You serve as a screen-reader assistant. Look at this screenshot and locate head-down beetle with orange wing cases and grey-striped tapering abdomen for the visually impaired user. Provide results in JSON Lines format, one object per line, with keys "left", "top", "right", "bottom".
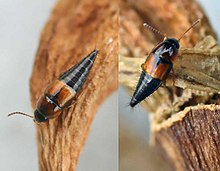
{"left": 8, "top": 50, "right": 98, "bottom": 123}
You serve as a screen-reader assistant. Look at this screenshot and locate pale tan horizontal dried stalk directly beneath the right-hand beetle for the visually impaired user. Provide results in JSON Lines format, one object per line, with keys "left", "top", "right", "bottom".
{"left": 119, "top": 36, "right": 220, "bottom": 93}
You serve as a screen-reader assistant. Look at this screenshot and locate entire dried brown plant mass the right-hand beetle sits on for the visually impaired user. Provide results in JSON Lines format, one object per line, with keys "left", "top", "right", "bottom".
{"left": 119, "top": 0, "right": 220, "bottom": 171}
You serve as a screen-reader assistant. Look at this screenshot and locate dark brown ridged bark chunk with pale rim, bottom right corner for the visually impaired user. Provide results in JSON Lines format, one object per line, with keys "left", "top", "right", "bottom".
{"left": 154, "top": 105, "right": 220, "bottom": 171}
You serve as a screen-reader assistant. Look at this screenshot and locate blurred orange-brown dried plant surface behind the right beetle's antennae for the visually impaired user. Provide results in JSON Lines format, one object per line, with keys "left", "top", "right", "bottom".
{"left": 120, "top": 0, "right": 216, "bottom": 57}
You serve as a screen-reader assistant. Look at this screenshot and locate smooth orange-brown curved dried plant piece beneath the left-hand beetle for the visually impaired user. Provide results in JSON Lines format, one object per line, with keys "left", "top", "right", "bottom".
{"left": 30, "top": 0, "right": 119, "bottom": 171}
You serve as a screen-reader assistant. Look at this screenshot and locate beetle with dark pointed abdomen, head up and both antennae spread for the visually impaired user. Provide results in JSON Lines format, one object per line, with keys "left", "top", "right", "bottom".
{"left": 130, "top": 19, "right": 200, "bottom": 107}
